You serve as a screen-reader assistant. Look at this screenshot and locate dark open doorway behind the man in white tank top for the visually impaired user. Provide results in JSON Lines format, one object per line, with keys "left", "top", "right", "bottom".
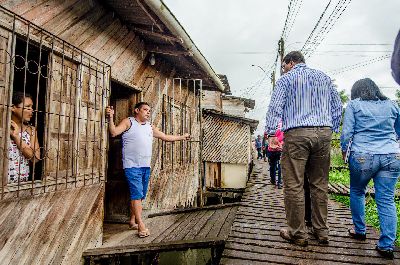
{"left": 105, "top": 81, "right": 140, "bottom": 222}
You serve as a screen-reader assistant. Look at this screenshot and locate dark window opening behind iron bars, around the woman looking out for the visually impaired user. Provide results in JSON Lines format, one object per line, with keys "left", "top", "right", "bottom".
{"left": 13, "top": 38, "right": 49, "bottom": 180}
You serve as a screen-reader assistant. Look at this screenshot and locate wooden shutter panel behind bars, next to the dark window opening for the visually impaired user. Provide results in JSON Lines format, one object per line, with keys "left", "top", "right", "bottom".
{"left": 44, "top": 54, "right": 78, "bottom": 178}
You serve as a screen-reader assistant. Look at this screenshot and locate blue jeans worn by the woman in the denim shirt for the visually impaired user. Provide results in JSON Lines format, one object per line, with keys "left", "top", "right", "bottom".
{"left": 349, "top": 152, "right": 400, "bottom": 250}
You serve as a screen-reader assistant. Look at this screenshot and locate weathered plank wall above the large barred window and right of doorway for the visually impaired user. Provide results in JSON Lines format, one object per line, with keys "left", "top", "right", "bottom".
{"left": 0, "top": 0, "right": 200, "bottom": 209}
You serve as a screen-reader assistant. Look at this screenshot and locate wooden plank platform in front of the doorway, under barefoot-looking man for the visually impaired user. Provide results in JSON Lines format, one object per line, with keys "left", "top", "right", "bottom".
{"left": 83, "top": 204, "right": 239, "bottom": 264}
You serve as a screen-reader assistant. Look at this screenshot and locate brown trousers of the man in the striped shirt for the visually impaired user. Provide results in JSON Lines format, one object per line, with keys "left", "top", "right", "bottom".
{"left": 281, "top": 127, "right": 332, "bottom": 239}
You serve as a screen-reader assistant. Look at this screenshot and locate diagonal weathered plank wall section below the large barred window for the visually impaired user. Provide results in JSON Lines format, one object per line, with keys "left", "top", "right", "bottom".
{"left": 0, "top": 184, "right": 104, "bottom": 265}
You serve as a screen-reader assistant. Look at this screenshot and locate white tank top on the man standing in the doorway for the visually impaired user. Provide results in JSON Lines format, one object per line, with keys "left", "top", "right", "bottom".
{"left": 122, "top": 117, "right": 153, "bottom": 168}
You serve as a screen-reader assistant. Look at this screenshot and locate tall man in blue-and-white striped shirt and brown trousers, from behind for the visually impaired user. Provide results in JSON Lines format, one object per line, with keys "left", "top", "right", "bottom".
{"left": 265, "top": 51, "right": 342, "bottom": 246}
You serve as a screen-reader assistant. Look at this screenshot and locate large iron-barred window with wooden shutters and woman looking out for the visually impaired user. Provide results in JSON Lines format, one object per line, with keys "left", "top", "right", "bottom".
{"left": 0, "top": 11, "right": 111, "bottom": 198}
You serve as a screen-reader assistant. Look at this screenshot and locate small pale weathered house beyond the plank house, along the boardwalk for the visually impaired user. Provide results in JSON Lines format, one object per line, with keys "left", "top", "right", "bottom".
{"left": 202, "top": 77, "right": 258, "bottom": 202}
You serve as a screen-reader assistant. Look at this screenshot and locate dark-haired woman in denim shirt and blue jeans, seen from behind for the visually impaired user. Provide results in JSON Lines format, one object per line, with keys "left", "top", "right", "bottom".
{"left": 340, "top": 78, "right": 400, "bottom": 259}
